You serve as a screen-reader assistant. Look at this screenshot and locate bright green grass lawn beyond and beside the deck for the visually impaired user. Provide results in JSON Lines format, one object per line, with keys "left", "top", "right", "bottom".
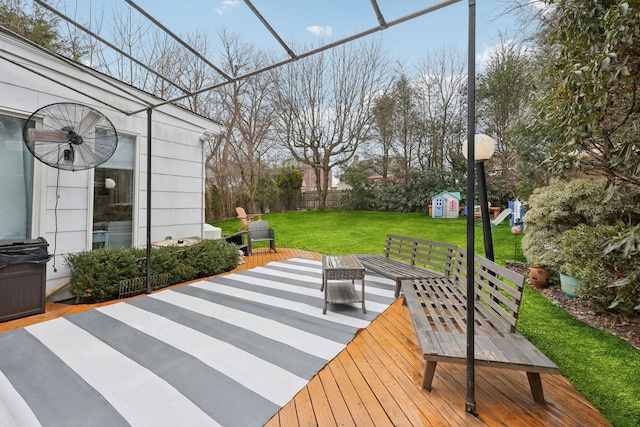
{"left": 214, "top": 211, "right": 640, "bottom": 427}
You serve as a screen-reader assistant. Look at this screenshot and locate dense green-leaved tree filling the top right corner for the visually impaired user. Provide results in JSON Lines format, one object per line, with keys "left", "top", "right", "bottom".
{"left": 538, "top": 0, "right": 640, "bottom": 185}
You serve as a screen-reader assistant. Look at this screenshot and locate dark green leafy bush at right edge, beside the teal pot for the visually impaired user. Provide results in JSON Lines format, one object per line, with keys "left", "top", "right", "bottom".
{"left": 563, "top": 224, "right": 640, "bottom": 316}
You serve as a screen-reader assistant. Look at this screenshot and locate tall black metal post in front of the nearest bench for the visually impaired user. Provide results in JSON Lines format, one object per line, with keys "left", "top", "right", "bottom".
{"left": 465, "top": 0, "right": 478, "bottom": 416}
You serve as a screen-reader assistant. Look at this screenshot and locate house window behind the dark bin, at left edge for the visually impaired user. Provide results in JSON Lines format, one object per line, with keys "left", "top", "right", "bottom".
{"left": 0, "top": 114, "right": 35, "bottom": 240}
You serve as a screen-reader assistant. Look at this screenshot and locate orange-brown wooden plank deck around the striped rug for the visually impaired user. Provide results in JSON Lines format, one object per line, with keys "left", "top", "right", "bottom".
{"left": 0, "top": 249, "right": 611, "bottom": 427}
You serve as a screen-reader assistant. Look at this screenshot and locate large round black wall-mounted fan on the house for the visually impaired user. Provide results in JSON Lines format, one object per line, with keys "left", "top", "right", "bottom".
{"left": 22, "top": 102, "right": 118, "bottom": 171}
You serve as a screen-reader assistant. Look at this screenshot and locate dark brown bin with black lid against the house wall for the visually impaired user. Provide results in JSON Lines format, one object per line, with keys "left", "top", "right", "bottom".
{"left": 0, "top": 237, "right": 51, "bottom": 322}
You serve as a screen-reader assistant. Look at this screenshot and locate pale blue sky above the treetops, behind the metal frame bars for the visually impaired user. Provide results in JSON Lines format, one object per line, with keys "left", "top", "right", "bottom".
{"left": 123, "top": 0, "right": 519, "bottom": 67}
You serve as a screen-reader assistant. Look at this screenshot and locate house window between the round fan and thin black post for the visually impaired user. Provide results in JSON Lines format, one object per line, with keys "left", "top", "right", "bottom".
{"left": 92, "top": 133, "right": 136, "bottom": 249}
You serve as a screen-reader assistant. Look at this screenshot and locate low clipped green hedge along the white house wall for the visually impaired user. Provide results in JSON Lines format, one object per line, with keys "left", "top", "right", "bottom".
{"left": 65, "top": 240, "right": 238, "bottom": 303}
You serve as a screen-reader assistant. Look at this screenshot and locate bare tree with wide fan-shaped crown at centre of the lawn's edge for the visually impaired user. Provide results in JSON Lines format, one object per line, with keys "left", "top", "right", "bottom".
{"left": 276, "top": 42, "right": 388, "bottom": 209}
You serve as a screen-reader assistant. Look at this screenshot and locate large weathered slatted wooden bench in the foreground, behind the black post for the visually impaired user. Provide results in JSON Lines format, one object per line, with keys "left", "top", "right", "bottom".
{"left": 402, "top": 242, "right": 560, "bottom": 404}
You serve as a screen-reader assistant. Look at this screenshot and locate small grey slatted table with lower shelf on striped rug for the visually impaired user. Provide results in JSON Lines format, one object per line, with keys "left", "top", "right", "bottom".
{"left": 320, "top": 255, "right": 367, "bottom": 314}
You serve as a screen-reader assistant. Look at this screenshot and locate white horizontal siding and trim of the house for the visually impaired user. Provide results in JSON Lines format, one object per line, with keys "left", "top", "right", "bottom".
{"left": 0, "top": 32, "right": 221, "bottom": 299}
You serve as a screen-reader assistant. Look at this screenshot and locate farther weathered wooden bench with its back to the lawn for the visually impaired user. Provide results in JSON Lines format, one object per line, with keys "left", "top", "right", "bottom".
{"left": 357, "top": 234, "right": 457, "bottom": 298}
